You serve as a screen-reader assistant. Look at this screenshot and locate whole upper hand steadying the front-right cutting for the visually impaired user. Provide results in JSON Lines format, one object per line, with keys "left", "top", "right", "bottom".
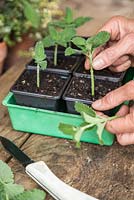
{"left": 85, "top": 16, "right": 134, "bottom": 72}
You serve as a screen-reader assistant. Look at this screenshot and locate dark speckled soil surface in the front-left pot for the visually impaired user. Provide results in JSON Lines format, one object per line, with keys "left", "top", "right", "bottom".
{"left": 12, "top": 70, "right": 67, "bottom": 96}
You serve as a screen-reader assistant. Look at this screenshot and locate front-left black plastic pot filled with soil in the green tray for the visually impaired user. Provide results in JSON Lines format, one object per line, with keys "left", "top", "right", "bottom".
{"left": 11, "top": 70, "right": 70, "bottom": 111}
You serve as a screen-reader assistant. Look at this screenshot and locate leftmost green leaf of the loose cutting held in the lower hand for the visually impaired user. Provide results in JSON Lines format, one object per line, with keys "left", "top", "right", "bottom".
{"left": 58, "top": 123, "right": 77, "bottom": 136}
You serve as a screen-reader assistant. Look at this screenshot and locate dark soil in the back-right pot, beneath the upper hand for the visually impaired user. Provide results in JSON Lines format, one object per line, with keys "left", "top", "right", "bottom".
{"left": 75, "top": 61, "right": 125, "bottom": 81}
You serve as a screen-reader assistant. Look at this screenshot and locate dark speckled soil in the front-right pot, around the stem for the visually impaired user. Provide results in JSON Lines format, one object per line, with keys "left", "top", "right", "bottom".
{"left": 65, "top": 77, "right": 119, "bottom": 101}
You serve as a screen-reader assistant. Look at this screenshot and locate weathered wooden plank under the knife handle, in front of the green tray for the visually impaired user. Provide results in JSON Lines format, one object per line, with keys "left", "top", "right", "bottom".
{"left": 9, "top": 135, "right": 134, "bottom": 200}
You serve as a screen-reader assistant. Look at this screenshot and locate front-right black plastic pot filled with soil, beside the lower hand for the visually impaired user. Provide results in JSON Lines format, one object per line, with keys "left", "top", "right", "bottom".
{"left": 63, "top": 77, "right": 120, "bottom": 116}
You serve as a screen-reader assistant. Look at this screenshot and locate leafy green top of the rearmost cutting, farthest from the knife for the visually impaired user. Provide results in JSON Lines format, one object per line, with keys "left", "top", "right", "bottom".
{"left": 49, "top": 8, "right": 92, "bottom": 29}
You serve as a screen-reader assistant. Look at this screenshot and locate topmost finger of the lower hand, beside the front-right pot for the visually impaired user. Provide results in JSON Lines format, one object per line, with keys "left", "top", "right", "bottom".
{"left": 92, "top": 80, "right": 134, "bottom": 111}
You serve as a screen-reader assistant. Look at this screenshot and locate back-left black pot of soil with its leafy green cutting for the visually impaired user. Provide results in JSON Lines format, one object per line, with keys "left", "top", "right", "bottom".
{"left": 26, "top": 26, "right": 81, "bottom": 75}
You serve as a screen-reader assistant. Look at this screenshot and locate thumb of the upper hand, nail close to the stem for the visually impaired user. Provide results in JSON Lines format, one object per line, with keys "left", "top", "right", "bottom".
{"left": 93, "top": 33, "right": 134, "bottom": 70}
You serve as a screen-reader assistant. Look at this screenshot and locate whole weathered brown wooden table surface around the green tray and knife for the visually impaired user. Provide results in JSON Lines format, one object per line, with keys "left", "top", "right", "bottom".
{"left": 0, "top": 0, "right": 134, "bottom": 200}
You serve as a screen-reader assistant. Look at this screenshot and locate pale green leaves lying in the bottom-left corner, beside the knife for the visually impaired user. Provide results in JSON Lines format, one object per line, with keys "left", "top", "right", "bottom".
{"left": 0, "top": 160, "right": 46, "bottom": 200}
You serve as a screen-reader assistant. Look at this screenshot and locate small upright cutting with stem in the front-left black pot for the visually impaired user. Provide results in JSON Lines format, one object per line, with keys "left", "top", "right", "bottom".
{"left": 33, "top": 41, "right": 47, "bottom": 88}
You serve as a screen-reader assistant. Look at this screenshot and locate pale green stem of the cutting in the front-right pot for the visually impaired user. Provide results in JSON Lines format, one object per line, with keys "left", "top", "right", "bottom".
{"left": 88, "top": 53, "right": 95, "bottom": 96}
